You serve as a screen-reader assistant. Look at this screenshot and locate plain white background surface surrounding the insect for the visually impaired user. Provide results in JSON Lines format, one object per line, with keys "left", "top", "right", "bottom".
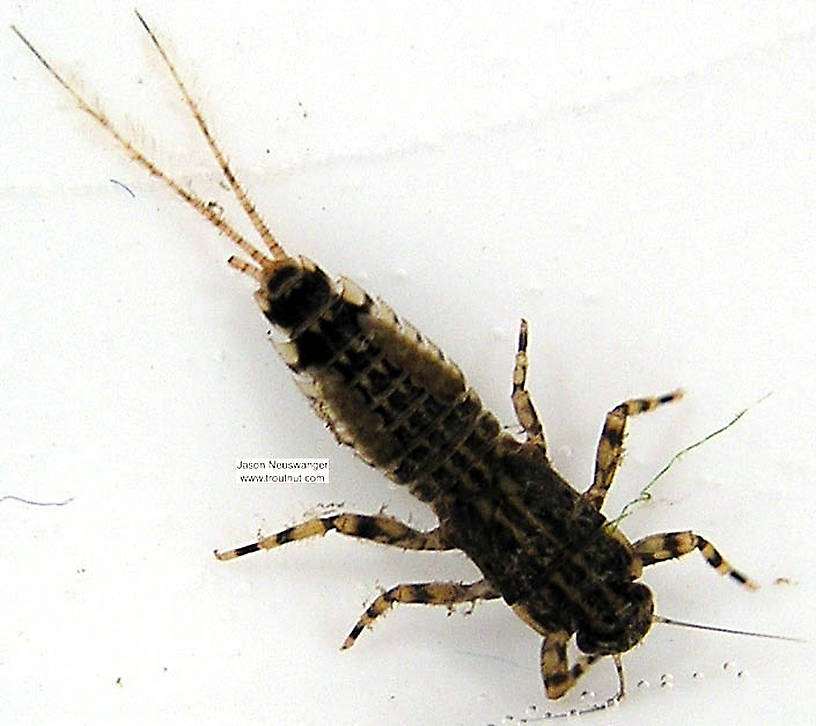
{"left": 0, "top": 0, "right": 816, "bottom": 725}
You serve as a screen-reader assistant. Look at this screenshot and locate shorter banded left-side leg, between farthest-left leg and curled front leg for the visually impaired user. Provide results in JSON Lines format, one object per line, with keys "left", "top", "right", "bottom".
{"left": 342, "top": 580, "right": 500, "bottom": 650}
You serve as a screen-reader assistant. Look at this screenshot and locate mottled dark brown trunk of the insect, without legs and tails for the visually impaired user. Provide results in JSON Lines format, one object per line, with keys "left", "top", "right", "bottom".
{"left": 256, "top": 259, "right": 651, "bottom": 656}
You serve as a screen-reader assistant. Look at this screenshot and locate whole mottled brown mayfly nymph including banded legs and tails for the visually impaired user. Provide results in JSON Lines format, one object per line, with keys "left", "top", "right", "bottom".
{"left": 15, "top": 16, "right": 753, "bottom": 710}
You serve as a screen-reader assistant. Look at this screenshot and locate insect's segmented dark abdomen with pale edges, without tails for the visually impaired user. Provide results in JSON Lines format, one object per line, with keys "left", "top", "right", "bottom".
{"left": 256, "top": 260, "right": 501, "bottom": 504}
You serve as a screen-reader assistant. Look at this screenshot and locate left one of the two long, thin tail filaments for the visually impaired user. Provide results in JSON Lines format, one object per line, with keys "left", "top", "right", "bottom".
{"left": 11, "top": 25, "right": 272, "bottom": 280}
